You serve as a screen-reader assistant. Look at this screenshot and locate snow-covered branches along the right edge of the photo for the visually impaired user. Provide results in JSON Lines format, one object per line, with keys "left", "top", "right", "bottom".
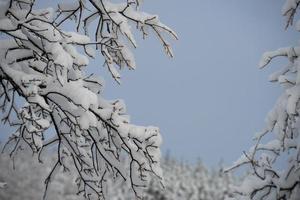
{"left": 228, "top": 0, "right": 300, "bottom": 200}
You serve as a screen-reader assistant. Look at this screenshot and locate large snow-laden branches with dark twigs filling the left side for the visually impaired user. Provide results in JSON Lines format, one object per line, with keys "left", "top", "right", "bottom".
{"left": 0, "top": 0, "right": 177, "bottom": 199}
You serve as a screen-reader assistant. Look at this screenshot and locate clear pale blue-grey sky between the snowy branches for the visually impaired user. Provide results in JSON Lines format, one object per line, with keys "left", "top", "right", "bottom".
{"left": 1, "top": 0, "right": 298, "bottom": 165}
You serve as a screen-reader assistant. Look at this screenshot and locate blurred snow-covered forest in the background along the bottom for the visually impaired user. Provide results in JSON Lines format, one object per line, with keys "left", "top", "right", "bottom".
{"left": 0, "top": 152, "right": 234, "bottom": 200}
